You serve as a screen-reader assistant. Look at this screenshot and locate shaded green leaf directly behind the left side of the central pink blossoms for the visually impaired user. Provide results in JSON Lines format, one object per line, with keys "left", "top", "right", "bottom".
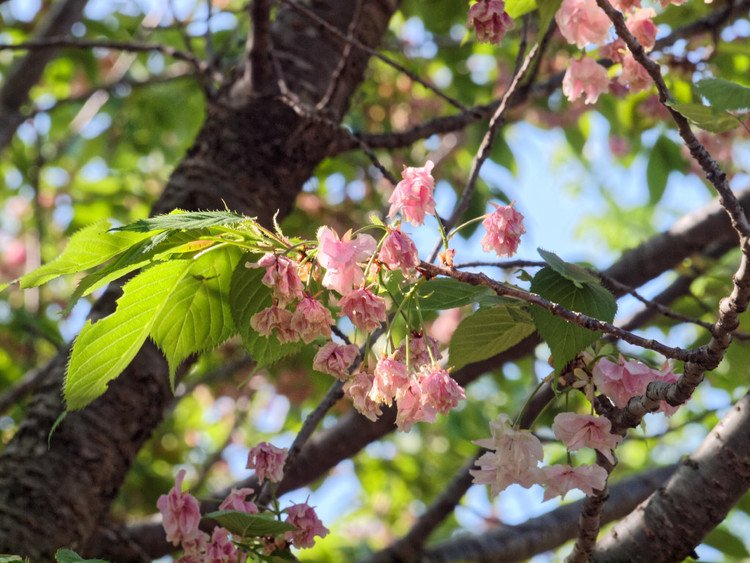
{"left": 229, "top": 254, "right": 302, "bottom": 367}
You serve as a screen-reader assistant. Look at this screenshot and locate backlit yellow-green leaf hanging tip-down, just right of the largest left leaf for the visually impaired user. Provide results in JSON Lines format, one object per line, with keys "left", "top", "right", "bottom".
{"left": 151, "top": 247, "right": 241, "bottom": 386}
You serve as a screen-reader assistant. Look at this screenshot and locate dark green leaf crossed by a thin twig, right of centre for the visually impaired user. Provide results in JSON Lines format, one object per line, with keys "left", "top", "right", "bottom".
{"left": 531, "top": 267, "right": 617, "bottom": 370}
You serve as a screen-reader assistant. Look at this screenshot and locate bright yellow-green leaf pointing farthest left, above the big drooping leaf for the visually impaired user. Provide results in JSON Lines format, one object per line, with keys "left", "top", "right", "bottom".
{"left": 19, "top": 220, "right": 152, "bottom": 288}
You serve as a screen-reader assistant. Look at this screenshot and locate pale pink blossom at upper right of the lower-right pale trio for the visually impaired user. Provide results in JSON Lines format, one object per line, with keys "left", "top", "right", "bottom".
{"left": 552, "top": 412, "right": 622, "bottom": 463}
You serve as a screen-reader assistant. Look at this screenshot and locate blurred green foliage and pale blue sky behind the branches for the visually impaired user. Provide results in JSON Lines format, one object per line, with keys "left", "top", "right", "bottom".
{"left": 0, "top": 0, "right": 750, "bottom": 561}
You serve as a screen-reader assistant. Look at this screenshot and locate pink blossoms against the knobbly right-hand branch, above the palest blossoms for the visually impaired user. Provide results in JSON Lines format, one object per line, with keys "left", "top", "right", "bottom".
{"left": 593, "top": 356, "right": 679, "bottom": 416}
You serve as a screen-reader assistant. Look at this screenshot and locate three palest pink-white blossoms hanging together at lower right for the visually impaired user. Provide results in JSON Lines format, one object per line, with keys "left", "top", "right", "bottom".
{"left": 470, "top": 413, "right": 621, "bottom": 500}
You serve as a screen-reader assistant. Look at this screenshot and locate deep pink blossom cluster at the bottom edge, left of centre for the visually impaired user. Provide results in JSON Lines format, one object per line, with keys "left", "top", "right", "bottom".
{"left": 156, "top": 442, "right": 328, "bottom": 563}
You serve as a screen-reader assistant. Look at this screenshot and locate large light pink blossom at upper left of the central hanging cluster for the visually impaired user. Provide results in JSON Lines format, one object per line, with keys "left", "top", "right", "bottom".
{"left": 318, "top": 227, "right": 377, "bottom": 295}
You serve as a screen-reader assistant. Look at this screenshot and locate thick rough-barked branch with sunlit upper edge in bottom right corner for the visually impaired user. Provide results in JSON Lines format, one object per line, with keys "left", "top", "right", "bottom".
{"left": 593, "top": 395, "right": 750, "bottom": 563}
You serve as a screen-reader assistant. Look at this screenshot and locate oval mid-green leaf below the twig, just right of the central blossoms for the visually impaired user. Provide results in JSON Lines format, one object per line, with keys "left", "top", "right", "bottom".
{"left": 449, "top": 305, "right": 534, "bottom": 369}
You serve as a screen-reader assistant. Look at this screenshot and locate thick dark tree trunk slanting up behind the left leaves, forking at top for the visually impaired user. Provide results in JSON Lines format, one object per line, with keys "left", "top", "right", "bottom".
{"left": 0, "top": 0, "right": 398, "bottom": 561}
